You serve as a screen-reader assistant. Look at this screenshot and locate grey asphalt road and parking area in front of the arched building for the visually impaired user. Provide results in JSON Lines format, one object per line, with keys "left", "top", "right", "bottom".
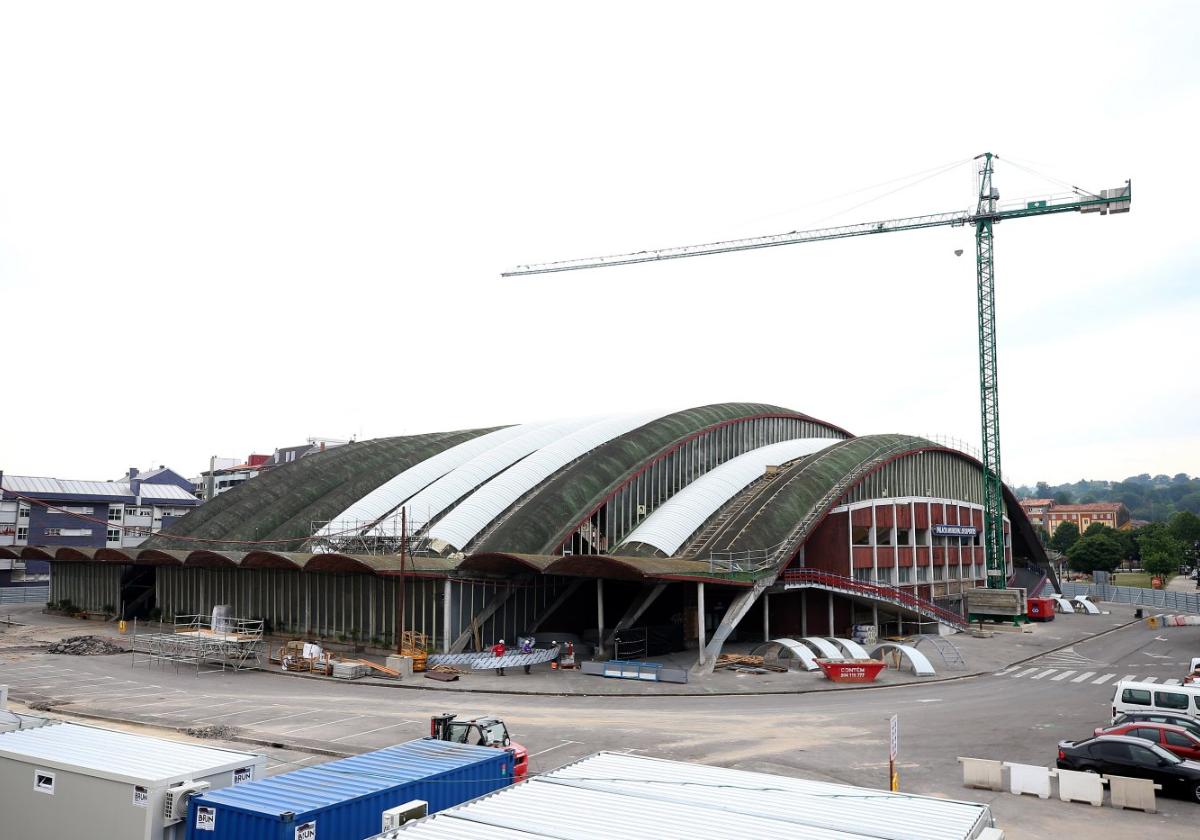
{"left": 0, "top": 606, "right": 1200, "bottom": 840}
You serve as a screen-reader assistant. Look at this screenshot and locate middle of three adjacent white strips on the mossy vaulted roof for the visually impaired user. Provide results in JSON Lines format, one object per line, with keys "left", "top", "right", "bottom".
{"left": 370, "top": 418, "right": 595, "bottom": 536}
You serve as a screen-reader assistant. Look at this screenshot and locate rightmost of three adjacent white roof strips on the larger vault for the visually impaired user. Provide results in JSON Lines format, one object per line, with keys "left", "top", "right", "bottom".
{"left": 427, "top": 412, "right": 672, "bottom": 548}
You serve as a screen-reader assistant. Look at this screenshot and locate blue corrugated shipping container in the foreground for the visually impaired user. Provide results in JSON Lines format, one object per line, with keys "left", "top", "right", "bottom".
{"left": 187, "top": 738, "right": 512, "bottom": 840}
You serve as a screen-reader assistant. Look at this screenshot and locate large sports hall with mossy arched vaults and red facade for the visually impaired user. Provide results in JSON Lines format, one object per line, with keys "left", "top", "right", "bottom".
{"left": 0, "top": 403, "right": 1052, "bottom": 667}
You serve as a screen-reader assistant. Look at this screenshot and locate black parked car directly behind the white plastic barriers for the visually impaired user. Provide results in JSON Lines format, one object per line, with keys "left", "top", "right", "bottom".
{"left": 1057, "top": 736, "right": 1200, "bottom": 803}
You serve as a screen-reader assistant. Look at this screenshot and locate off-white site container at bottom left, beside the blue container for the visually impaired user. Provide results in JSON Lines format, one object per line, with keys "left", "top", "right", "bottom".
{"left": 0, "top": 724, "right": 266, "bottom": 840}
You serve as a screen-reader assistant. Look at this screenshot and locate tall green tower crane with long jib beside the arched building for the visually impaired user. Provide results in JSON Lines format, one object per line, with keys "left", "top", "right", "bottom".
{"left": 500, "top": 152, "right": 1132, "bottom": 589}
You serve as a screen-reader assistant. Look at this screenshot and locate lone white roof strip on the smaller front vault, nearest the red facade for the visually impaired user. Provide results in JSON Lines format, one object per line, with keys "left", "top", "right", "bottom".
{"left": 622, "top": 438, "right": 836, "bottom": 556}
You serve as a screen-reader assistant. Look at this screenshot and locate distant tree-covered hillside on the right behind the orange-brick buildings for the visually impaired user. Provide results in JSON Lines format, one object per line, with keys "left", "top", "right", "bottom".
{"left": 1015, "top": 473, "right": 1200, "bottom": 522}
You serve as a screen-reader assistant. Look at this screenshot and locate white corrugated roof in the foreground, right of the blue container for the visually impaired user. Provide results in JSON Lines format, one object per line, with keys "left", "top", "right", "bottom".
{"left": 384, "top": 752, "right": 992, "bottom": 840}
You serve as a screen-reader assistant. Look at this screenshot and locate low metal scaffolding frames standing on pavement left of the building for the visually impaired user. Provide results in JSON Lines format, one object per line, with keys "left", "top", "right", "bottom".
{"left": 130, "top": 616, "right": 264, "bottom": 674}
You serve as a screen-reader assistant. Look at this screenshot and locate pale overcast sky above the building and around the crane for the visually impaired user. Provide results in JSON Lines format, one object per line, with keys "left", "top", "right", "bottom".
{"left": 0, "top": 0, "right": 1200, "bottom": 484}
